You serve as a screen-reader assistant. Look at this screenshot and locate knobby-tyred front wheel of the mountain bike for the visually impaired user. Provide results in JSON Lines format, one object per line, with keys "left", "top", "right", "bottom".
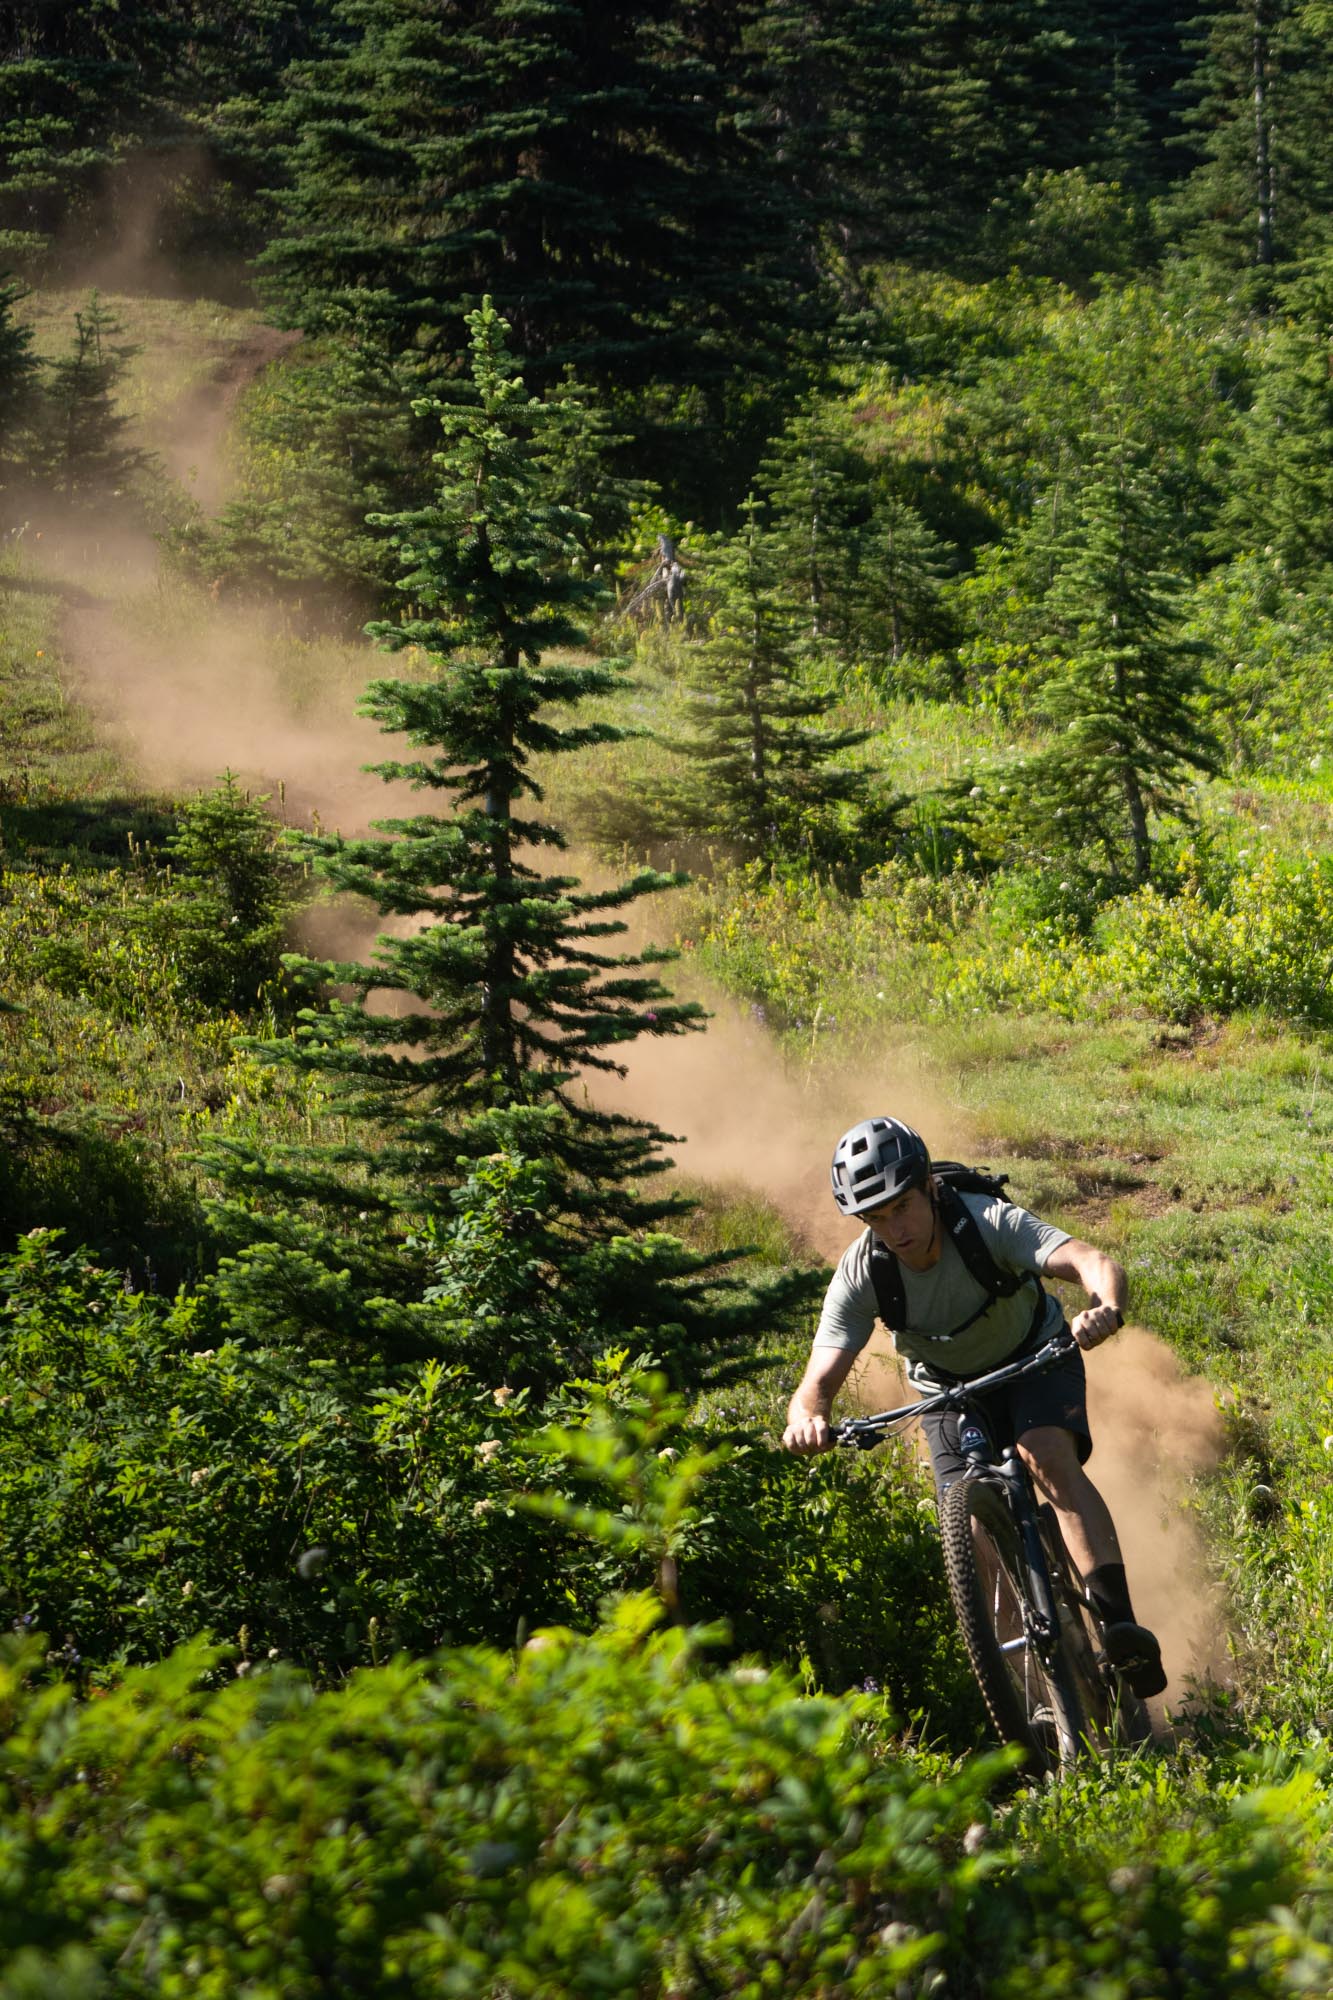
{"left": 939, "top": 1476, "right": 1087, "bottom": 1774}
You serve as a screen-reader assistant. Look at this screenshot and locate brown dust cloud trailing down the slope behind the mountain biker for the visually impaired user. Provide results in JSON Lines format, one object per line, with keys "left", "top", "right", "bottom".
{"left": 36, "top": 296, "right": 1223, "bottom": 1694}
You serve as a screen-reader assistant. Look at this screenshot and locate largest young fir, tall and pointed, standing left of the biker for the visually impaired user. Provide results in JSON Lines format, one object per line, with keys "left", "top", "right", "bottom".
{"left": 202, "top": 302, "right": 809, "bottom": 1386}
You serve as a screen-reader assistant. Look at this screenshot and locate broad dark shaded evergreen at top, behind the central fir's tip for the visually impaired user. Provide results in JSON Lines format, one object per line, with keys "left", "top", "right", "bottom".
{"left": 260, "top": 0, "right": 813, "bottom": 406}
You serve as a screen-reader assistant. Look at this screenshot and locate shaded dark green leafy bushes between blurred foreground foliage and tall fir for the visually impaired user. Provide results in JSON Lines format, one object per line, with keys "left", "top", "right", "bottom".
{"left": 0, "top": 1232, "right": 979, "bottom": 1742}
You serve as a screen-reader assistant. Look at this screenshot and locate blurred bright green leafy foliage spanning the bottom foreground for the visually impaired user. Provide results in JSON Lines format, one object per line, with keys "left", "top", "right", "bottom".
{"left": 0, "top": 1596, "right": 1333, "bottom": 2000}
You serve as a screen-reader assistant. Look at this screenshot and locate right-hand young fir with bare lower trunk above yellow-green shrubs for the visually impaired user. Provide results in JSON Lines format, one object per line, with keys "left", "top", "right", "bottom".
{"left": 999, "top": 440, "right": 1217, "bottom": 888}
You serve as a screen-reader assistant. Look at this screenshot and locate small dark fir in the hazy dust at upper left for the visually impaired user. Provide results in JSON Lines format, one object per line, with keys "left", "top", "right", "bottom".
{"left": 36, "top": 292, "right": 148, "bottom": 506}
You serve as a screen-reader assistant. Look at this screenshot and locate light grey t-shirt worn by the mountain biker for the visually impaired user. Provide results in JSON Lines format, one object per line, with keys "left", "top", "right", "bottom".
{"left": 815, "top": 1194, "right": 1069, "bottom": 1386}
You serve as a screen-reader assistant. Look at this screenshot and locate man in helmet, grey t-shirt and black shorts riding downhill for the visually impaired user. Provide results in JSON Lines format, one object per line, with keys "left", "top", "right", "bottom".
{"left": 783, "top": 1118, "right": 1167, "bottom": 1696}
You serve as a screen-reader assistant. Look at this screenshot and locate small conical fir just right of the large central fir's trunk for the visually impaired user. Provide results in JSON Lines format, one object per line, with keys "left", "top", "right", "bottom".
{"left": 667, "top": 496, "right": 869, "bottom": 864}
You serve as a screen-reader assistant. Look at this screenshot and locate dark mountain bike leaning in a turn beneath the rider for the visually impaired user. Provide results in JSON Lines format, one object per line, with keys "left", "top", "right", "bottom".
{"left": 833, "top": 1332, "right": 1153, "bottom": 1776}
